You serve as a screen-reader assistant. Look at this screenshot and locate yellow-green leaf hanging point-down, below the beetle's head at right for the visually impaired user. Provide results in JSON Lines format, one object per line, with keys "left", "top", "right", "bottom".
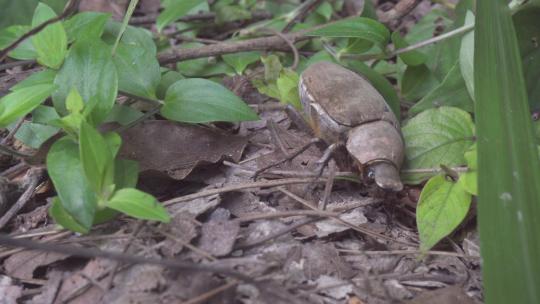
{"left": 416, "top": 175, "right": 471, "bottom": 252}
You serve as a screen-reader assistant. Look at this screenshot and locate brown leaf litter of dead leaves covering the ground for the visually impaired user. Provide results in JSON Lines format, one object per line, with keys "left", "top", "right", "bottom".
{"left": 0, "top": 0, "right": 482, "bottom": 304}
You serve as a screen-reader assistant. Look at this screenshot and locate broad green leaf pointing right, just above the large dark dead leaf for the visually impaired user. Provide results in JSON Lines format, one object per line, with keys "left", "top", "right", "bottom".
{"left": 161, "top": 78, "right": 259, "bottom": 123}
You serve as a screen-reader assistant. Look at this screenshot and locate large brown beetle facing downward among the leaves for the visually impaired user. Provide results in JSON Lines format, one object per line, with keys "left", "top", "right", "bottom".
{"left": 298, "top": 61, "right": 404, "bottom": 191}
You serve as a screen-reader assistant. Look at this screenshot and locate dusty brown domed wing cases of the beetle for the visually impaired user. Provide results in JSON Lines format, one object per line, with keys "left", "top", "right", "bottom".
{"left": 300, "top": 62, "right": 398, "bottom": 127}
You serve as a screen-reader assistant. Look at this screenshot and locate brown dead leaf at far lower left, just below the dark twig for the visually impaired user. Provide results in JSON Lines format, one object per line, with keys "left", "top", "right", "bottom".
{"left": 4, "top": 250, "right": 68, "bottom": 279}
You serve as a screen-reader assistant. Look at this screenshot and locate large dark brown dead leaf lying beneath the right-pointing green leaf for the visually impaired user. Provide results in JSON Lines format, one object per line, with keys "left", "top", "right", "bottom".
{"left": 120, "top": 120, "right": 247, "bottom": 180}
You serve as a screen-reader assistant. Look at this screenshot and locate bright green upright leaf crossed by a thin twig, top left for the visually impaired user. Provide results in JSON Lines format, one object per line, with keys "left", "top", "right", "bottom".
{"left": 32, "top": 3, "right": 67, "bottom": 69}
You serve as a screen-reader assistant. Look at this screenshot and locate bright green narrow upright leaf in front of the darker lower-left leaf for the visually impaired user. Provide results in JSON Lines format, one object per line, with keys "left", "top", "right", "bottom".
{"left": 79, "top": 121, "right": 114, "bottom": 199}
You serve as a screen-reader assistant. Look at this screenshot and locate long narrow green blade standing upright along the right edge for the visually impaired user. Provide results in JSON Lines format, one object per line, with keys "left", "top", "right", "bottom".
{"left": 474, "top": 0, "right": 540, "bottom": 304}
